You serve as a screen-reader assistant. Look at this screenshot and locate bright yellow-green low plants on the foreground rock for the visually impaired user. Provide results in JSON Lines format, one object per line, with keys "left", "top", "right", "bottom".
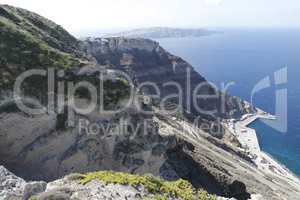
{"left": 80, "top": 171, "right": 216, "bottom": 200}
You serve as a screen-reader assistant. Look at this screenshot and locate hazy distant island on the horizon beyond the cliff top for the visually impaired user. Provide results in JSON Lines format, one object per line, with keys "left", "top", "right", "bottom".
{"left": 104, "top": 27, "right": 220, "bottom": 39}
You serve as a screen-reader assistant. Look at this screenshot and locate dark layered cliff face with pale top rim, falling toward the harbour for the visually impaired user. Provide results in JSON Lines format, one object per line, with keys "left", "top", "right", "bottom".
{"left": 84, "top": 38, "right": 254, "bottom": 121}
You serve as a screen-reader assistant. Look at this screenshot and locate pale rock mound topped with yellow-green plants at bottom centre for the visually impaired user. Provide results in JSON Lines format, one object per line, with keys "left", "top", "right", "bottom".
{"left": 32, "top": 171, "right": 226, "bottom": 200}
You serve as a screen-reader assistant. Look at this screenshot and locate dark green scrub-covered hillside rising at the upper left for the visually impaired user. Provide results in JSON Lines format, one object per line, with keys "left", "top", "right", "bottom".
{"left": 0, "top": 5, "right": 86, "bottom": 87}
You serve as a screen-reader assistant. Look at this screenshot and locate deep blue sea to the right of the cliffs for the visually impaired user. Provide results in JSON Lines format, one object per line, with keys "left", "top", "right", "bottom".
{"left": 158, "top": 29, "right": 300, "bottom": 176}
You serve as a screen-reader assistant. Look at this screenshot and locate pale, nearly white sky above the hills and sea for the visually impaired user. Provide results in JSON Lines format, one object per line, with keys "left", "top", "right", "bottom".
{"left": 0, "top": 0, "right": 300, "bottom": 35}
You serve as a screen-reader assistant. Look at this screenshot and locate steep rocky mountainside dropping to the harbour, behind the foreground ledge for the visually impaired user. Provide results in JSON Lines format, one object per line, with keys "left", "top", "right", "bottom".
{"left": 0, "top": 6, "right": 300, "bottom": 200}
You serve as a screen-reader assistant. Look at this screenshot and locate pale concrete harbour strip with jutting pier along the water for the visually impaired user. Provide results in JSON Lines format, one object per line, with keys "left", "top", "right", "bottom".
{"left": 225, "top": 109, "right": 300, "bottom": 183}
